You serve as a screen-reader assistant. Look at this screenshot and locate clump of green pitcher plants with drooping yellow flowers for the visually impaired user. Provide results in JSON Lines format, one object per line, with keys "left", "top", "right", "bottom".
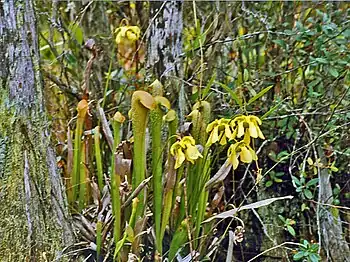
{"left": 66, "top": 77, "right": 264, "bottom": 261}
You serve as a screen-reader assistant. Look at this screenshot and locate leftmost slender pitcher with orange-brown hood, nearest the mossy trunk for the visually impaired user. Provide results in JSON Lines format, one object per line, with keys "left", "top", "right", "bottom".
{"left": 72, "top": 99, "right": 88, "bottom": 203}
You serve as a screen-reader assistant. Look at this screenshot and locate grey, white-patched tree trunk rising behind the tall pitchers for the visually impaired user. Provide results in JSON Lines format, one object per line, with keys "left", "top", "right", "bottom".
{"left": 147, "top": 1, "right": 186, "bottom": 122}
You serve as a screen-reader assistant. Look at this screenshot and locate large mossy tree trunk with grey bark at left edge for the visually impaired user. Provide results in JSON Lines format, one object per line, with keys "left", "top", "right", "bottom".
{"left": 0, "top": 0, "right": 73, "bottom": 261}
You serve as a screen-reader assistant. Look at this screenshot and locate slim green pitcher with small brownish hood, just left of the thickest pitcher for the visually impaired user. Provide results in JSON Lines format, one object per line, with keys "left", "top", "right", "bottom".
{"left": 111, "top": 112, "right": 125, "bottom": 247}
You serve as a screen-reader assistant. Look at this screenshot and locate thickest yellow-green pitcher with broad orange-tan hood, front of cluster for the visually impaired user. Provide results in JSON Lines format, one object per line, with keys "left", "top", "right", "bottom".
{"left": 131, "top": 91, "right": 155, "bottom": 219}
